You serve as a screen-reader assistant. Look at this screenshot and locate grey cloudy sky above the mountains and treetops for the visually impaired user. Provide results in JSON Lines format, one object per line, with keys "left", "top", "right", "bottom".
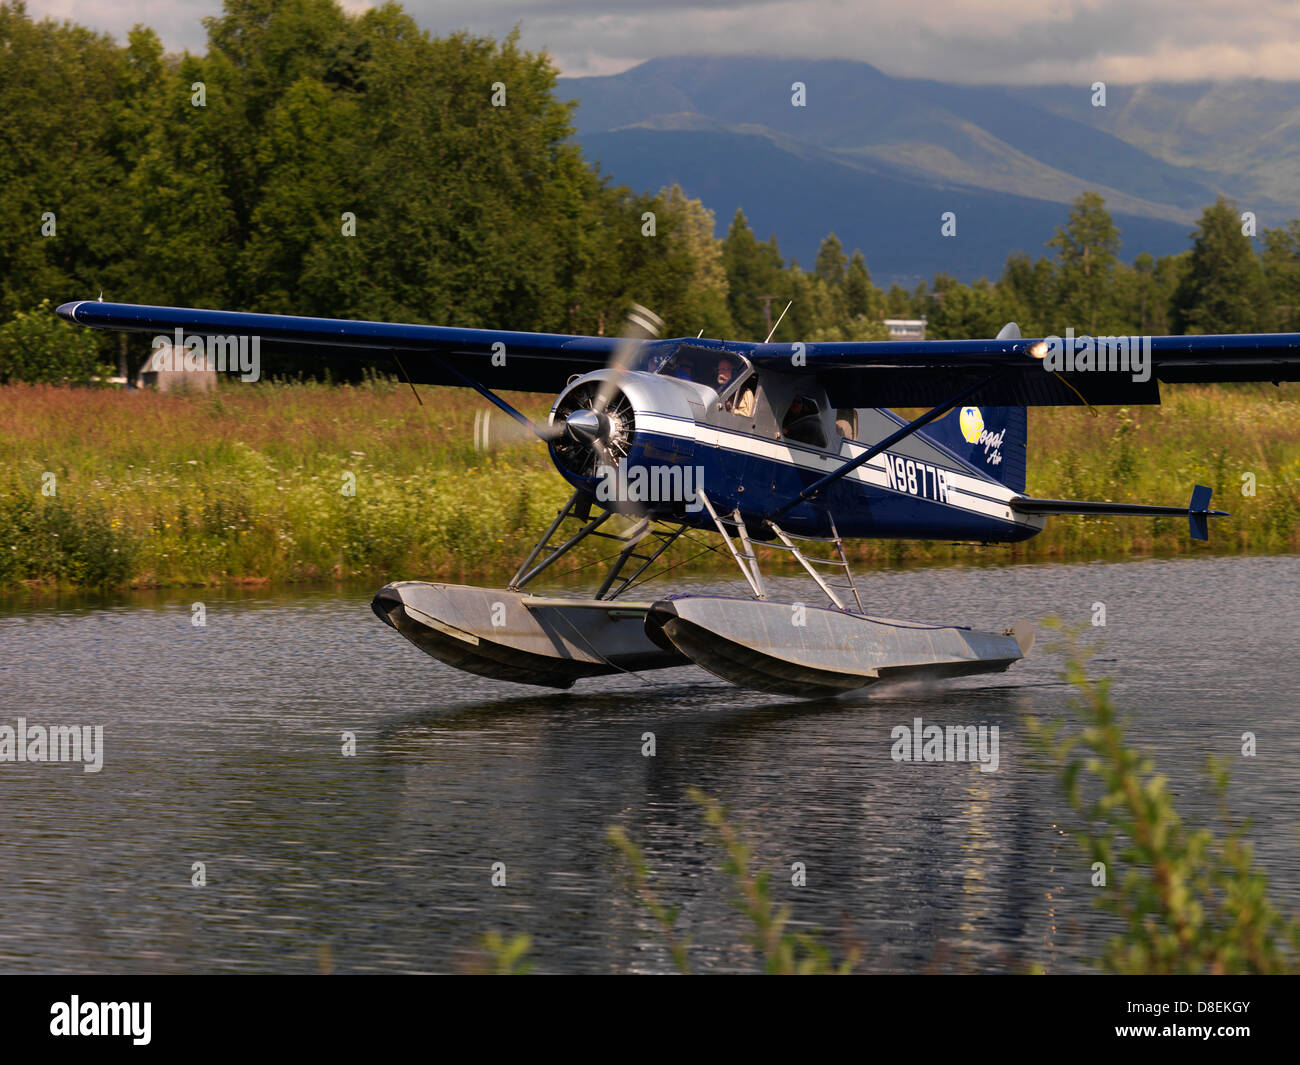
{"left": 27, "top": 0, "right": 1300, "bottom": 83}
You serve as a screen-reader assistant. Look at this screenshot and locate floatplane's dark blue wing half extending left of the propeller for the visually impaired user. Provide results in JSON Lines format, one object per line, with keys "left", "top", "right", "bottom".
{"left": 59, "top": 300, "right": 619, "bottom": 394}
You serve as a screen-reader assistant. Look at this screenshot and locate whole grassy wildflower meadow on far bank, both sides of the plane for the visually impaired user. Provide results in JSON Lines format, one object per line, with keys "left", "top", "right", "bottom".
{"left": 0, "top": 380, "right": 1300, "bottom": 590}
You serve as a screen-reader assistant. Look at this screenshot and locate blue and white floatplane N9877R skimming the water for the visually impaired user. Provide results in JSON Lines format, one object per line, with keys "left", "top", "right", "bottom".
{"left": 59, "top": 300, "right": 1300, "bottom": 697}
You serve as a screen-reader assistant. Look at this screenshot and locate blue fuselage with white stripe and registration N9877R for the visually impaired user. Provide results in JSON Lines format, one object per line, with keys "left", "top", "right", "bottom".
{"left": 551, "top": 352, "right": 1044, "bottom": 542}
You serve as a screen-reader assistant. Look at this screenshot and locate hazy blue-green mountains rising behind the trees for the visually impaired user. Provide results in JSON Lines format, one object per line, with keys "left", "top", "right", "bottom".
{"left": 559, "top": 56, "right": 1300, "bottom": 287}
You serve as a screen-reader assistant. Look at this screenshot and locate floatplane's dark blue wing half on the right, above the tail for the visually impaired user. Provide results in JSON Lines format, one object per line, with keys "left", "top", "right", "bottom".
{"left": 746, "top": 333, "right": 1300, "bottom": 407}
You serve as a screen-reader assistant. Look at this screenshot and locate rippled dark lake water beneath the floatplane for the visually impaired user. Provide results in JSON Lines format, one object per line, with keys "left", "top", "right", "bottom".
{"left": 0, "top": 557, "right": 1300, "bottom": 973}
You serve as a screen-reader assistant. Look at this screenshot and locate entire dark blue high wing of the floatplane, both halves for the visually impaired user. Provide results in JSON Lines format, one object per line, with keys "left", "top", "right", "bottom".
{"left": 59, "top": 300, "right": 1300, "bottom": 407}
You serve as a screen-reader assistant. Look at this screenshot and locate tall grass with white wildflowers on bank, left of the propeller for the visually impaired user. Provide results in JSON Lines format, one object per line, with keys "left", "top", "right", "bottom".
{"left": 0, "top": 381, "right": 564, "bottom": 586}
